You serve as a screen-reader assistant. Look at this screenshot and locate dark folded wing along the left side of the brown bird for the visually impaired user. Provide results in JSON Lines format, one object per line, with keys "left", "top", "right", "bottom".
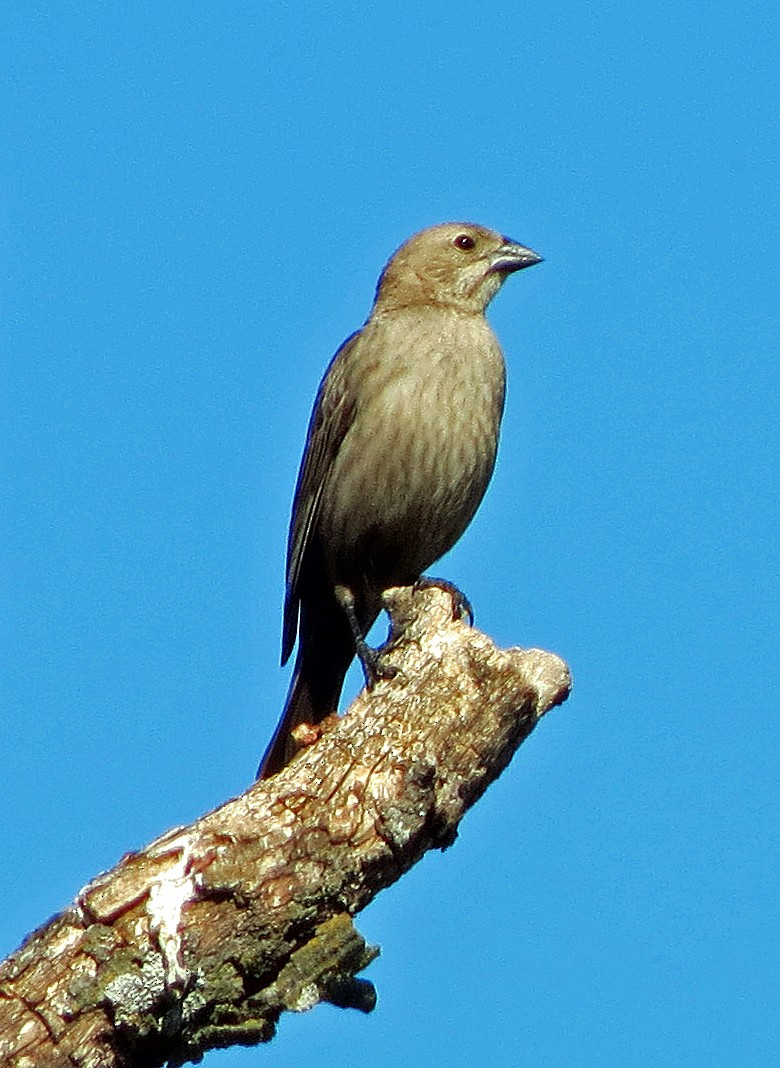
{"left": 282, "top": 331, "right": 361, "bottom": 664}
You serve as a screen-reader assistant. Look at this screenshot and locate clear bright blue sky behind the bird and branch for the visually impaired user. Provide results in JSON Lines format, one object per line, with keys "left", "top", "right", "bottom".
{"left": 0, "top": 0, "right": 780, "bottom": 1068}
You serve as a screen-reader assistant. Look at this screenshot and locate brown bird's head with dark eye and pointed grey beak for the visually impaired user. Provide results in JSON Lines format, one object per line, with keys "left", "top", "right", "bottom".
{"left": 375, "top": 222, "right": 542, "bottom": 313}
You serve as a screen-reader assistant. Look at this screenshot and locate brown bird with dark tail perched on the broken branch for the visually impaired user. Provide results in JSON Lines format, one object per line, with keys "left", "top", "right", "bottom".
{"left": 258, "top": 222, "right": 542, "bottom": 778}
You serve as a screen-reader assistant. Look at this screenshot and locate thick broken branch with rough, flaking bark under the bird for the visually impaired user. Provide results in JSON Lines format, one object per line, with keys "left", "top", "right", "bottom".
{"left": 0, "top": 588, "right": 571, "bottom": 1068}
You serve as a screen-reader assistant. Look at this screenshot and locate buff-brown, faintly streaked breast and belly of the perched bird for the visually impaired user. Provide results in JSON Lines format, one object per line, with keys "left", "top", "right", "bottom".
{"left": 318, "top": 313, "right": 504, "bottom": 584}
